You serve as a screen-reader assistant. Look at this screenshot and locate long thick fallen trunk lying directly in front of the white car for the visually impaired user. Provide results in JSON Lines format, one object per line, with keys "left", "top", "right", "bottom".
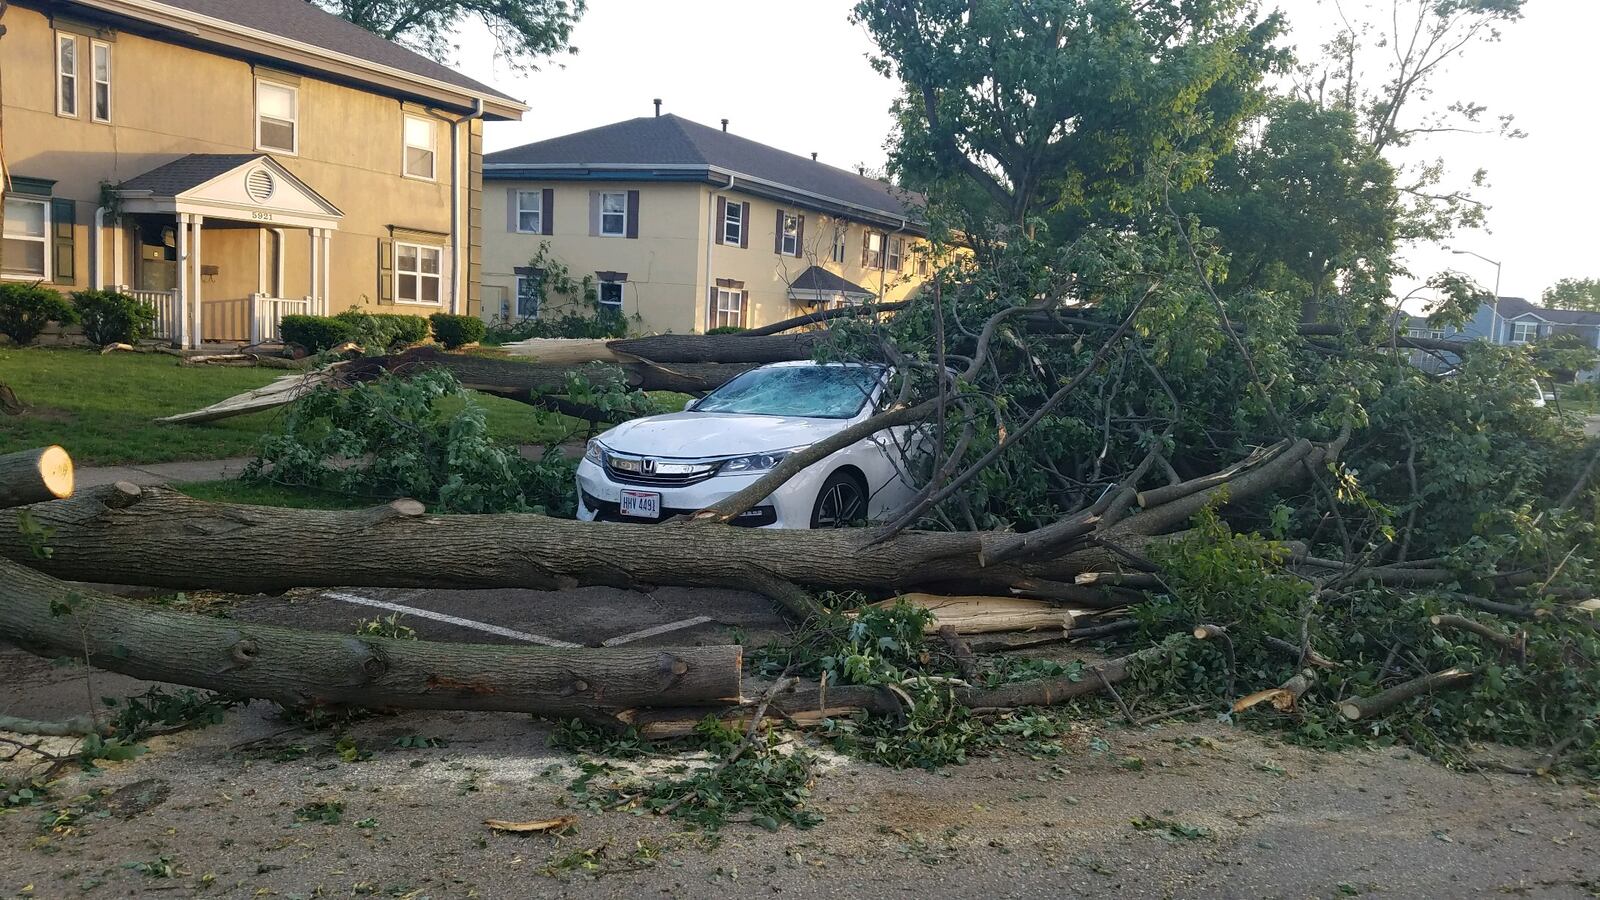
{"left": 0, "top": 487, "right": 1142, "bottom": 595}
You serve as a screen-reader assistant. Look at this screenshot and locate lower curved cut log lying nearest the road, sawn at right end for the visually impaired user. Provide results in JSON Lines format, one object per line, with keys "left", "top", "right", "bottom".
{"left": 0, "top": 550, "right": 741, "bottom": 716}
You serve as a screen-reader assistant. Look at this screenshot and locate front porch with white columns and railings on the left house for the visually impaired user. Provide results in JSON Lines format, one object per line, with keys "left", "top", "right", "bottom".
{"left": 94, "top": 154, "right": 342, "bottom": 348}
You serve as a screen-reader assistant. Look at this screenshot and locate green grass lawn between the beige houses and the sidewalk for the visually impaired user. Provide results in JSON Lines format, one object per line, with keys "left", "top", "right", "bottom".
{"left": 0, "top": 348, "right": 582, "bottom": 466}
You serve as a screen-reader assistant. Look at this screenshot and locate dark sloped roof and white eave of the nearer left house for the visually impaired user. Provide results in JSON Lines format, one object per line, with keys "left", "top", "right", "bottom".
{"left": 60, "top": 0, "right": 528, "bottom": 119}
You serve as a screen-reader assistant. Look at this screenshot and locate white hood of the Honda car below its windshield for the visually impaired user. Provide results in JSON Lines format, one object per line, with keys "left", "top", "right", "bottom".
{"left": 600, "top": 412, "right": 850, "bottom": 460}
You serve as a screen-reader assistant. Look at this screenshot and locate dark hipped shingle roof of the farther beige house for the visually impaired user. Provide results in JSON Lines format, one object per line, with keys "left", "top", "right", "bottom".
{"left": 483, "top": 114, "right": 923, "bottom": 232}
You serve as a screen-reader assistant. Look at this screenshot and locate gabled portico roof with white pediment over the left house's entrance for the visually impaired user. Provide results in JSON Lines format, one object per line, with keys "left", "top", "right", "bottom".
{"left": 117, "top": 154, "right": 344, "bottom": 229}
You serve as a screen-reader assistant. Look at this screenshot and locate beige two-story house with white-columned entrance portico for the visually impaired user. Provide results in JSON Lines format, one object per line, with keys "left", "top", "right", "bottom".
{"left": 0, "top": 0, "right": 526, "bottom": 346}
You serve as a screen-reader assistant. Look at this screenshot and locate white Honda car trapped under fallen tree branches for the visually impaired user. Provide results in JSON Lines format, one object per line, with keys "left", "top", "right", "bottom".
{"left": 578, "top": 362, "right": 914, "bottom": 528}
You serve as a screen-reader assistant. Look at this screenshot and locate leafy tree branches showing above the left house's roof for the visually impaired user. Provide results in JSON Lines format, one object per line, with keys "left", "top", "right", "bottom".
{"left": 307, "top": 0, "right": 587, "bottom": 70}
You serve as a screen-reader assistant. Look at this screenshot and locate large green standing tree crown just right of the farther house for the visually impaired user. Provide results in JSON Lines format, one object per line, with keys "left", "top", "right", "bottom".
{"left": 853, "top": 0, "right": 1280, "bottom": 237}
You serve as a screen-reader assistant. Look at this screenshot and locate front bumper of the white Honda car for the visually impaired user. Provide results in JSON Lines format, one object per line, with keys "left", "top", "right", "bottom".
{"left": 578, "top": 460, "right": 819, "bottom": 528}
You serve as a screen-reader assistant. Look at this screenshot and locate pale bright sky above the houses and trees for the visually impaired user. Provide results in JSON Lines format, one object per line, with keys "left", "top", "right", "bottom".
{"left": 456, "top": 0, "right": 1600, "bottom": 309}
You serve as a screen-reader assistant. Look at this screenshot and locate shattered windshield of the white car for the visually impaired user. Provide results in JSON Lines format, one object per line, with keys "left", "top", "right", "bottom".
{"left": 694, "top": 365, "right": 883, "bottom": 418}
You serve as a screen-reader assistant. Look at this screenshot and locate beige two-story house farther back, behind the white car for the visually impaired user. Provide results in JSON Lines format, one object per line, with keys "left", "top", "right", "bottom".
{"left": 483, "top": 114, "right": 930, "bottom": 333}
